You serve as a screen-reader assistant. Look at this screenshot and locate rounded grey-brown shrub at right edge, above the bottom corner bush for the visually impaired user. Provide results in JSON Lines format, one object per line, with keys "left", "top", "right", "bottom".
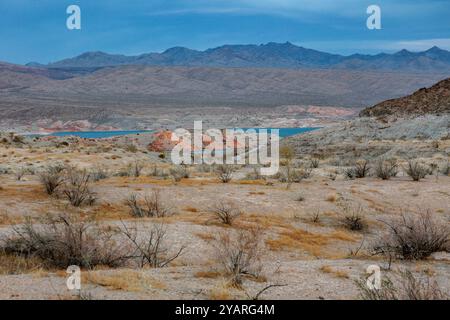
{"left": 373, "top": 212, "right": 450, "bottom": 260}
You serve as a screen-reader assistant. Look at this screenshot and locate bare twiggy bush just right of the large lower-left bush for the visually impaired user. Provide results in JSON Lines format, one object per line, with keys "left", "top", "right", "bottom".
{"left": 122, "top": 223, "right": 185, "bottom": 268}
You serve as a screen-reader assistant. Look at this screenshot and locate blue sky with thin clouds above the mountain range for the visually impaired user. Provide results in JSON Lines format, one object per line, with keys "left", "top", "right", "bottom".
{"left": 0, "top": 0, "right": 450, "bottom": 63}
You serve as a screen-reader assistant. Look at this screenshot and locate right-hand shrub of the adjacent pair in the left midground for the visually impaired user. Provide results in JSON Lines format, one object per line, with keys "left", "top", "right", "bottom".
{"left": 62, "top": 168, "right": 97, "bottom": 207}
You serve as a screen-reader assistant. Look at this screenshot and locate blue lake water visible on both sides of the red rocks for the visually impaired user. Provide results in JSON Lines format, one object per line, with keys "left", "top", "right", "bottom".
{"left": 45, "top": 128, "right": 320, "bottom": 139}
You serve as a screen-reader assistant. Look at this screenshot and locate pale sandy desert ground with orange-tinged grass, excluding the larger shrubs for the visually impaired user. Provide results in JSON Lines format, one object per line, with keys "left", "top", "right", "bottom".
{"left": 0, "top": 131, "right": 450, "bottom": 299}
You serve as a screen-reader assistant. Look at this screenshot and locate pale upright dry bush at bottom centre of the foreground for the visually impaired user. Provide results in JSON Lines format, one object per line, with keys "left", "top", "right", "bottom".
{"left": 211, "top": 229, "right": 262, "bottom": 286}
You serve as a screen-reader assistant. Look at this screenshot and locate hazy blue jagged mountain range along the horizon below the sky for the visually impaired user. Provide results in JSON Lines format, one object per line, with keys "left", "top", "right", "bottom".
{"left": 36, "top": 42, "right": 450, "bottom": 73}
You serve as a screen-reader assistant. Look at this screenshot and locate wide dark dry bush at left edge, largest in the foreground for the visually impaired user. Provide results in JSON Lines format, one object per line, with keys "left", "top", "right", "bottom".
{"left": 1, "top": 215, "right": 129, "bottom": 268}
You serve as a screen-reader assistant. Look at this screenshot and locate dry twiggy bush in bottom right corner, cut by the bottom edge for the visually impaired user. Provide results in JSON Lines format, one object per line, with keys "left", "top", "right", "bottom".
{"left": 356, "top": 270, "right": 449, "bottom": 300}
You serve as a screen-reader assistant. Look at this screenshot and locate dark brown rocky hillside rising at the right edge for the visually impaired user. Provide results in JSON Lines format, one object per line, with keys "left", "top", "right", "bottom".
{"left": 360, "top": 78, "right": 450, "bottom": 119}
